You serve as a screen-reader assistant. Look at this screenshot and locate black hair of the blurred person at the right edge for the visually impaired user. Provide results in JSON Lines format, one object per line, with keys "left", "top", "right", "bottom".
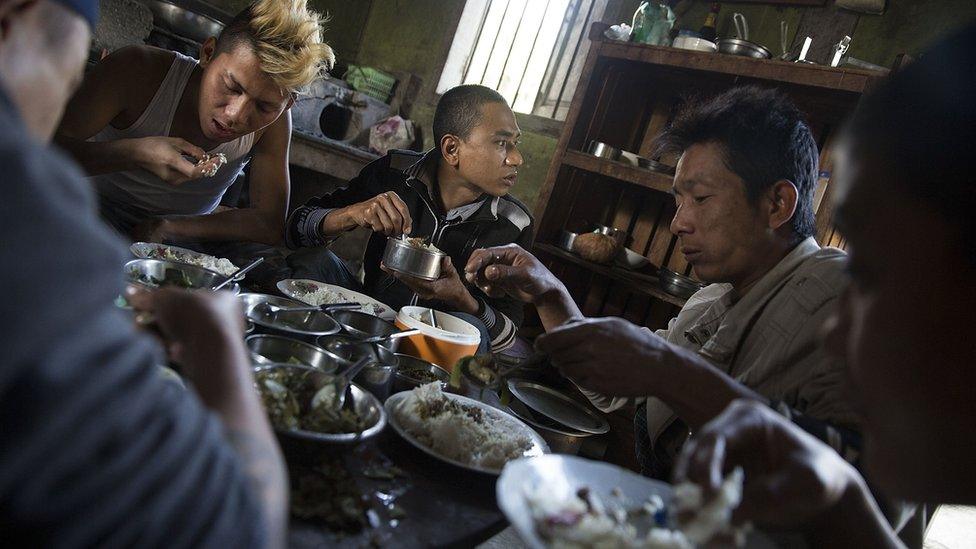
{"left": 837, "top": 25, "right": 976, "bottom": 265}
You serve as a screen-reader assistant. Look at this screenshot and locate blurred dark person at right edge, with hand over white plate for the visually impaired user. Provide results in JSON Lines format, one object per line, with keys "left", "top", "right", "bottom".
{"left": 676, "top": 23, "right": 976, "bottom": 548}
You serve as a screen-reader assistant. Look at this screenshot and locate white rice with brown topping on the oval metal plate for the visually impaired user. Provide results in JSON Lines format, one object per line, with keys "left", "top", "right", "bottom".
{"left": 394, "top": 383, "right": 532, "bottom": 469}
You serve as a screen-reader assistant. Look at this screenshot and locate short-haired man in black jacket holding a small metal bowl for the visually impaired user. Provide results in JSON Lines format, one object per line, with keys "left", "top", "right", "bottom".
{"left": 286, "top": 85, "right": 532, "bottom": 351}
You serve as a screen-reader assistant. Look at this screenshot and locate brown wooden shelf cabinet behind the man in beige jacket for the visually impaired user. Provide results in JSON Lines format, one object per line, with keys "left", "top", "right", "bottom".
{"left": 534, "top": 23, "right": 885, "bottom": 328}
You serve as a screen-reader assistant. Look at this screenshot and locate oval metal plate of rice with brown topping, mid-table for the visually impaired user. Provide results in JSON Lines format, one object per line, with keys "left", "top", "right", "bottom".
{"left": 385, "top": 382, "right": 549, "bottom": 475}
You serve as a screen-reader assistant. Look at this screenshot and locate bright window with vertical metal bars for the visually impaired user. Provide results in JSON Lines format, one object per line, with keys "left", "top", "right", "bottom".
{"left": 437, "top": 0, "right": 608, "bottom": 120}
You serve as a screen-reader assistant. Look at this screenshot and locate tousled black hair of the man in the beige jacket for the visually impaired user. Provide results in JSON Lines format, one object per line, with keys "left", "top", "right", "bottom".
{"left": 656, "top": 86, "right": 820, "bottom": 242}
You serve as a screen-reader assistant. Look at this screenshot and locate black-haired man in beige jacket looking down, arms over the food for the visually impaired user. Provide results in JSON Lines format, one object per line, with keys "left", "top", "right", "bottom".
{"left": 466, "top": 87, "right": 860, "bottom": 478}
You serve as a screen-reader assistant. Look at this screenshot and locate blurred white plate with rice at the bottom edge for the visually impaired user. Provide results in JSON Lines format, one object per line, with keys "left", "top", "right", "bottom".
{"left": 495, "top": 454, "right": 775, "bottom": 549}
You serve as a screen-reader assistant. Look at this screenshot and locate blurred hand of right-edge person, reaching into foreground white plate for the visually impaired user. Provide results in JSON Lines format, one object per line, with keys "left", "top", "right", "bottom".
{"left": 675, "top": 400, "right": 866, "bottom": 527}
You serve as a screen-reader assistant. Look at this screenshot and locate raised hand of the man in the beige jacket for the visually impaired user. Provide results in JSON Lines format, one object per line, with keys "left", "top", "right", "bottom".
{"left": 464, "top": 244, "right": 563, "bottom": 303}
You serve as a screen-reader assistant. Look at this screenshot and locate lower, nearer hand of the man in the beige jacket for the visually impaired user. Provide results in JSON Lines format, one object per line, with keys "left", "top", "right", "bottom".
{"left": 536, "top": 318, "right": 676, "bottom": 397}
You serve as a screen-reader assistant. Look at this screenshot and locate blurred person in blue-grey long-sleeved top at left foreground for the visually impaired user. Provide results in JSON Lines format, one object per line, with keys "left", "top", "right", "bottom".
{"left": 0, "top": 0, "right": 288, "bottom": 547}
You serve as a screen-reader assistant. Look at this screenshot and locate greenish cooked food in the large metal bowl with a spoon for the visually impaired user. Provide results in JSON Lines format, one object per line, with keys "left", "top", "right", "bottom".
{"left": 254, "top": 368, "right": 366, "bottom": 434}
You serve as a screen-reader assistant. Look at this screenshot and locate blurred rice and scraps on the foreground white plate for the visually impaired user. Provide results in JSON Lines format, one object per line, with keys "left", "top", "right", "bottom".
{"left": 526, "top": 469, "right": 747, "bottom": 549}
